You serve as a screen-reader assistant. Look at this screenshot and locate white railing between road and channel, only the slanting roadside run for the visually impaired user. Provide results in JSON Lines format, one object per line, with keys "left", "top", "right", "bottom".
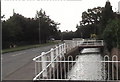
{"left": 33, "top": 43, "right": 77, "bottom": 80}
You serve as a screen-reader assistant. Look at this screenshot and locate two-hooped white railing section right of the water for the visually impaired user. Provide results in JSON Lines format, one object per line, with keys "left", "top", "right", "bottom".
{"left": 101, "top": 55, "right": 120, "bottom": 81}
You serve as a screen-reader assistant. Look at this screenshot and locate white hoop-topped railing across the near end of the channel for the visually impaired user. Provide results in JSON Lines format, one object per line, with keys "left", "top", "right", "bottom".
{"left": 33, "top": 55, "right": 120, "bottom": 81}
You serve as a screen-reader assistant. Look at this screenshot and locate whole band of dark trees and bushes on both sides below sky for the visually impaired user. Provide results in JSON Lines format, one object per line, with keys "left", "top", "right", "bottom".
{"left": 2, "top": 1, "right": 120, "bottom": 52}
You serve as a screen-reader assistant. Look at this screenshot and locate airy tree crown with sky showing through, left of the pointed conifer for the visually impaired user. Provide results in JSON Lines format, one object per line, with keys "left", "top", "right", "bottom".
{"left": 80, "top": 7, "right": 103, "bottom": 26}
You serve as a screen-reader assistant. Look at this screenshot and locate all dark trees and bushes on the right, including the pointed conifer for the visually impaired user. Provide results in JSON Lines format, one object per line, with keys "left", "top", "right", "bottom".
{"left": 63, "top": 1, "right": 120, "bottom": 50}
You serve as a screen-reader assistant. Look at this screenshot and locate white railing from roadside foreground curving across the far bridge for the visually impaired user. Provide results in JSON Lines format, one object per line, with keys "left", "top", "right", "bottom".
{"left": 33, "top": 40, "right": 103, "bottom": 80}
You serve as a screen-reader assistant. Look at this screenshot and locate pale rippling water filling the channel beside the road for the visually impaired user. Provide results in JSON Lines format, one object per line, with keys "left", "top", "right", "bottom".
{"left": 67, "top": 48, "right": 105, "bottom": 80}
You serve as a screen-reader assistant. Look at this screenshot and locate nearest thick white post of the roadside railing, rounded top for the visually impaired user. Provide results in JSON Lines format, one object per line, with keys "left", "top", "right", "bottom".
{"left": 41, "top": 52, "right": 47, "bottom": 78}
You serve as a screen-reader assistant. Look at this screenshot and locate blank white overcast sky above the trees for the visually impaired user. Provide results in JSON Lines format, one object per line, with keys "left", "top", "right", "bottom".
{"left": 1, "top": 0, "right": 120, "bottom": 31}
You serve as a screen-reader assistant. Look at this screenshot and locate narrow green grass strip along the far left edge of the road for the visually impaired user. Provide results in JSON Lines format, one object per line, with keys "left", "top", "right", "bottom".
{"left": 2, "top": 42, "right": 58, "bottom": 53}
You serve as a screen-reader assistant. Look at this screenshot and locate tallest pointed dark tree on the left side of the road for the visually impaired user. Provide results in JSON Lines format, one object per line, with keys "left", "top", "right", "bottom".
{"left": 36, "top": 9, "right": 60, "bottom": 43}
